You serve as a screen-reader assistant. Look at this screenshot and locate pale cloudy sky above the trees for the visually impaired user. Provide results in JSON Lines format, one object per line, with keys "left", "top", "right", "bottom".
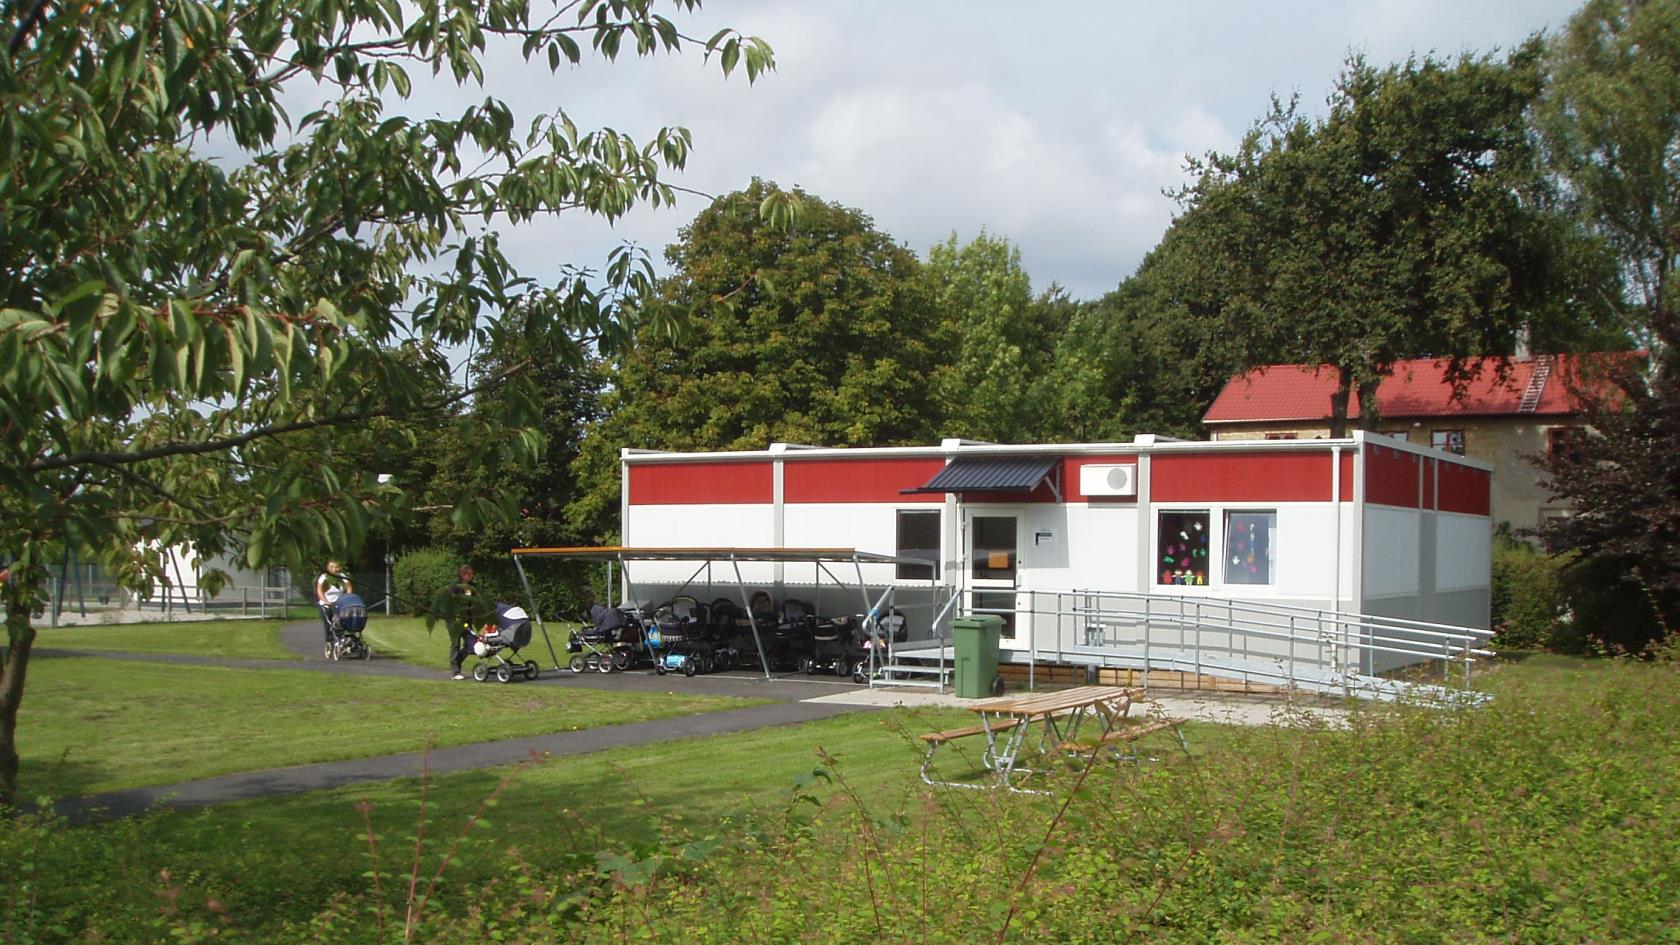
{"left": 436, "top": 0, "right": 1578, "bottom": 298}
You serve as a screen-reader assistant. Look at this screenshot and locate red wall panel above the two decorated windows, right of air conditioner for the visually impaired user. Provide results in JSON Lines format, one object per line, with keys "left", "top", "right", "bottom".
{"left": 1149, "top": 451, "right": 1331, "bottom": 503}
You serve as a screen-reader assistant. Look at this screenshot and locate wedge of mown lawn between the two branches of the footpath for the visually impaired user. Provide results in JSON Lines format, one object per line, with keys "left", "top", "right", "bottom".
{"left": 17, "top": 657, "right": 756, "bottom": 795}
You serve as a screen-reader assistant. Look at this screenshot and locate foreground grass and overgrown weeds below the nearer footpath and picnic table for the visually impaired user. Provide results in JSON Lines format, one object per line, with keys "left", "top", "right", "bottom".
{"left": 0, "top": 656, "right": 1680, "bottom": 945}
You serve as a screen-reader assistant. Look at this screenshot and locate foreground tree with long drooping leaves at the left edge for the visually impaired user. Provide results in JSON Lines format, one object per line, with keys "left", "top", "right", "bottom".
{"left": 0, "top": 0, "right": 773, "bottom": 805}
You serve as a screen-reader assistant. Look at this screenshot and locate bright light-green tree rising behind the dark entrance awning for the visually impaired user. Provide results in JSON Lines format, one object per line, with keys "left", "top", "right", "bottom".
{"left": 924, "top": 230, "right": 1065, "bottom": 442}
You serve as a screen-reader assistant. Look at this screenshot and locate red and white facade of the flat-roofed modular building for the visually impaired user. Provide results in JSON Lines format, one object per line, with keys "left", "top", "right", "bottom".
{"left": 622, "top": 432, "right": 1492, "bottom": 649}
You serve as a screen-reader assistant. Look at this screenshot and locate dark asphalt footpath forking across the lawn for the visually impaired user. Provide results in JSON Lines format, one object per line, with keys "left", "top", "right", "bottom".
{"left": 35, "top": 622, "right": 879, "bottom": 822}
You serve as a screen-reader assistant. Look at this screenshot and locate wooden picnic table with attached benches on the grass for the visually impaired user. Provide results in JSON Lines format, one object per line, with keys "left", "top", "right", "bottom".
{"left": 922, "top": 686, "right": 1132, "bottom": 794}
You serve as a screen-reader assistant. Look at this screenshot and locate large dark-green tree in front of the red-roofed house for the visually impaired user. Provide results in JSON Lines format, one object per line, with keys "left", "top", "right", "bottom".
{"left": 1158, "top": 40, "right": 1603, "bottom": 436}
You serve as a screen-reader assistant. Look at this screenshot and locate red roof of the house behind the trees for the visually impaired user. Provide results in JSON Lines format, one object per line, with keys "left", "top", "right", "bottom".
{"left": 1201, "top": 355, "right": 1606, "bottom": 424}
